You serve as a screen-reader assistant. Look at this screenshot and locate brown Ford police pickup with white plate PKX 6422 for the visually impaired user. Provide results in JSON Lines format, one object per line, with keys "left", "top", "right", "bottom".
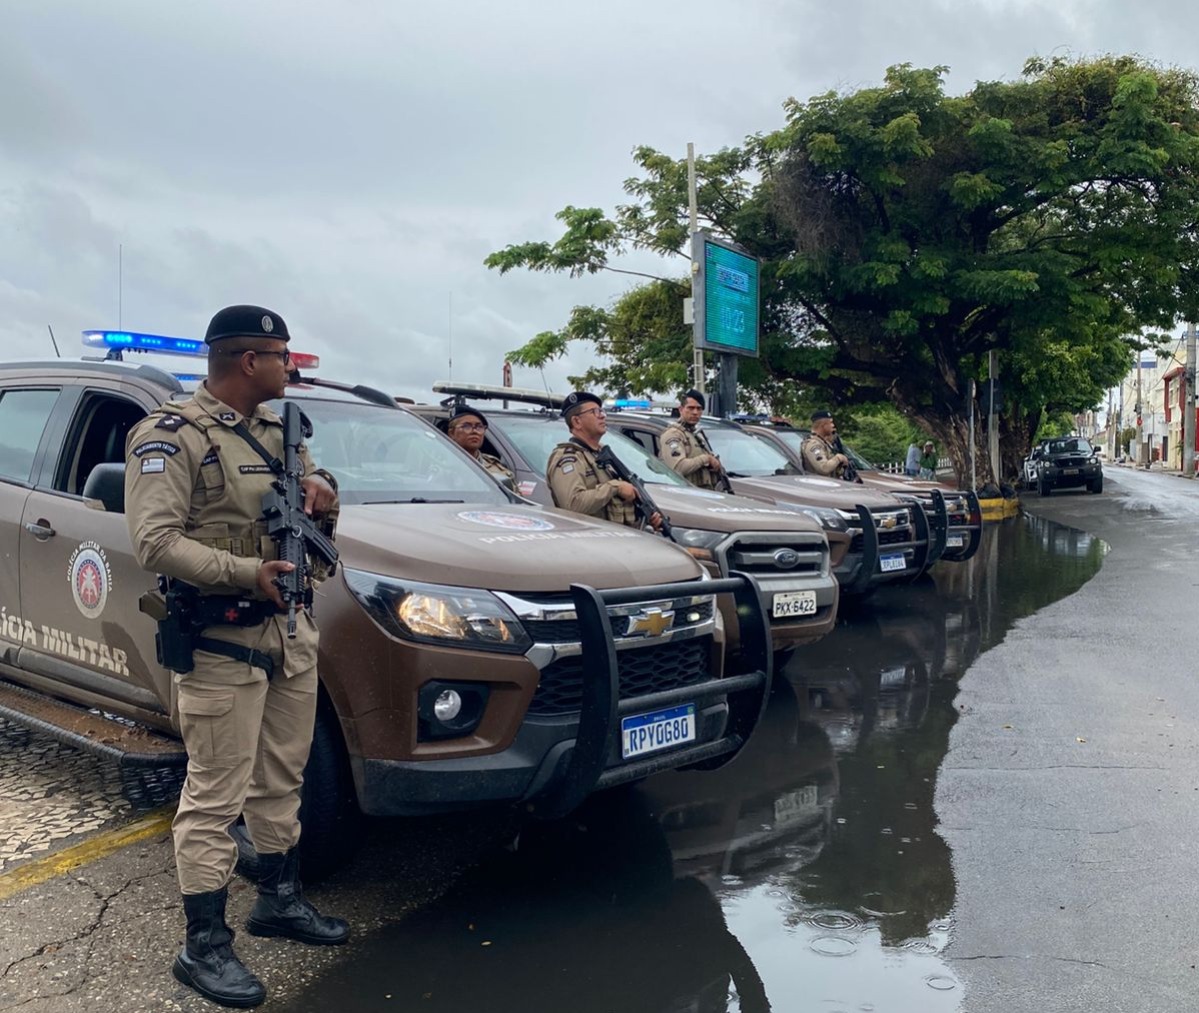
{"left": 411, "top": 384, "right": 849, "bottom": 651}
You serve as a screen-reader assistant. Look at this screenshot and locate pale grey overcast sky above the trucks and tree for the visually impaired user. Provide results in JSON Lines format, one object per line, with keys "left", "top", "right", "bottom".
{"left": 0, "top": 0, "right": 1199, "bottom": 399}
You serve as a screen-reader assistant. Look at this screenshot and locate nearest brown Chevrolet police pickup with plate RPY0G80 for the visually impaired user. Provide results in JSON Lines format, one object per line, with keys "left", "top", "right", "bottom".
{"left": 0, "top": 345, "right": 772, "bottom": 868}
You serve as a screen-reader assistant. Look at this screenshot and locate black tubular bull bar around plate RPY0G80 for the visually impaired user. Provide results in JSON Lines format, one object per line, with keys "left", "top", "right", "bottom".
{"left": 528, "top": 572, "right": 773, "bottom": 819}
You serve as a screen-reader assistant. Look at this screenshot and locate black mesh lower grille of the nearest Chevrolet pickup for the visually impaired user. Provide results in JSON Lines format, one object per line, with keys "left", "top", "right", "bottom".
{"left": 529, "top": 637, "right": 712, "bottom": 716}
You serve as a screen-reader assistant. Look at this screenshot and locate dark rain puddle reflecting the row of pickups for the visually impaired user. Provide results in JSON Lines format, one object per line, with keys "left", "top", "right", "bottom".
{"left": 287, "top": 517, "right": 1103, "bottom": 1013}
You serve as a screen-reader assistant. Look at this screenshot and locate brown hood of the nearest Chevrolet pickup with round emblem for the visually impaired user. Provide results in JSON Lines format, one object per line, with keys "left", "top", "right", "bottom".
{"left": 337, "top": 504, "right": 703, "bottom": 592}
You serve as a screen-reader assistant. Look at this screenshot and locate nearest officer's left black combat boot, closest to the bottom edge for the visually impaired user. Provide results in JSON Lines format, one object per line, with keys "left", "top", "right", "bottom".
{"left": 171, "top": 887, "right": 266, "bottom": 1009}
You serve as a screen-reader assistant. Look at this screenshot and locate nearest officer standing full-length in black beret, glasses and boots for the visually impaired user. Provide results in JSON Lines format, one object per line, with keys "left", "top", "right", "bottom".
{"left": 126, "top": 306, "right": 349, "bottom": 1007}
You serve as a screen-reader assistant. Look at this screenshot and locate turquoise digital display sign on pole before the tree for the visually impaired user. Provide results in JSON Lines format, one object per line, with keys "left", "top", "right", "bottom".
{"left": 691, "top": 233, "right": 759, "bottom": 357}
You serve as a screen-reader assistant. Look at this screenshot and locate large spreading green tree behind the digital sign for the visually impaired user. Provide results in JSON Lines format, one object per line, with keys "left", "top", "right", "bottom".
{"left": 487, "top": 56, "right": 1199, "bottom": 482}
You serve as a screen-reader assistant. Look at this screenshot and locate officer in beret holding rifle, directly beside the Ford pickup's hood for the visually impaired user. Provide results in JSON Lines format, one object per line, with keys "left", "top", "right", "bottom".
{"left": 546, "top": 391, "right": 662, "bottom": 527}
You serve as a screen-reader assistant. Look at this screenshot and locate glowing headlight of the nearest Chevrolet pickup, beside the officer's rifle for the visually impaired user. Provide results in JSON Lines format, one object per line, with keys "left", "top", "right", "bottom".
{"left": 342, "top": 567, "right": 532, "bottom": 655}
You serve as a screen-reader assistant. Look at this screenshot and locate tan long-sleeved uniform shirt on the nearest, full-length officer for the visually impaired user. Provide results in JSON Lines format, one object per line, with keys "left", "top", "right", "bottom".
{"left": 125, "top": 385, "right": 336, "bottom": 676}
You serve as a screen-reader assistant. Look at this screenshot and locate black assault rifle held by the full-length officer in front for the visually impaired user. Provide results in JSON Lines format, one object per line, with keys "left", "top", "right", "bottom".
{"left": 263, "top": 402, "right": 337, "bottom": 638}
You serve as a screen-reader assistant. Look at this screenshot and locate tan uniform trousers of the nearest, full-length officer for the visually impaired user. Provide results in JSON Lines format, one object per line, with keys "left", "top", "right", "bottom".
{"left": 171, "top": 631, "right": 317, "bottom": 894}
